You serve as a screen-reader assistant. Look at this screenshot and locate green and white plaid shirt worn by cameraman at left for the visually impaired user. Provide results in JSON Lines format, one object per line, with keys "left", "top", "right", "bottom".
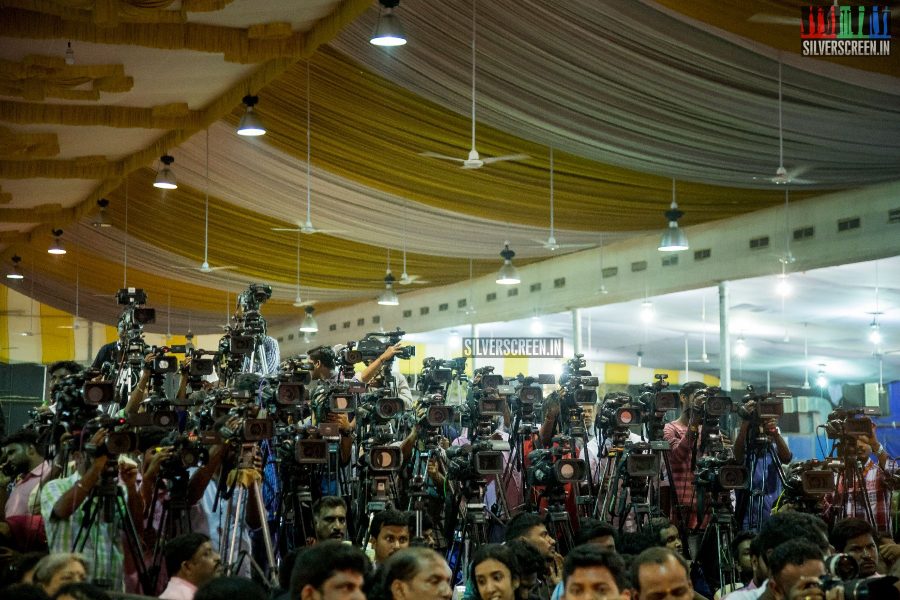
{"left": 41, "top": 473, "right": 127, "bottom": 591}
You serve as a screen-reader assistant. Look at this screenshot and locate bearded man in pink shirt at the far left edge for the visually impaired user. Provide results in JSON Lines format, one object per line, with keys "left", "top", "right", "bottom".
{"left": 0, "top": 429, "right": 57, "bottom": 552}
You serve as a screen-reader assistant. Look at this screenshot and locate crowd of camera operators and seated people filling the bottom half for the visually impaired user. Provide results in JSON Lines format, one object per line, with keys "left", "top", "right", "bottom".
{"left": 0, "top": 308, "right": 900, "bottom": 600}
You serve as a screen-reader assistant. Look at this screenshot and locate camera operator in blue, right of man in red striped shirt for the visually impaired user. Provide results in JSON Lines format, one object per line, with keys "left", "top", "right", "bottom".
{"left": 734, "top": 400, "right": 793, "bottom": 530}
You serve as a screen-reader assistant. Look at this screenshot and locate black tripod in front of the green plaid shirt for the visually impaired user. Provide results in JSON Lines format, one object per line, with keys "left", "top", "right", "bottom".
{"left": 72, "top": 462, "right": 156, "bottom": 595}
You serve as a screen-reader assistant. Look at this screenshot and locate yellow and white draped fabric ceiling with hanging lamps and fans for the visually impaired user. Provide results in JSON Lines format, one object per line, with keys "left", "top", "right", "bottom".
{"left": 0, "top": 0, "right": 900, "bottom": 338}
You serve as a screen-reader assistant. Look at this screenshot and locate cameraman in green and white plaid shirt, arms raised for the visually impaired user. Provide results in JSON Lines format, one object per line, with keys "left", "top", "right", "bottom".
{"left": 41, "top": 428, "right": 144, "bottom": 591}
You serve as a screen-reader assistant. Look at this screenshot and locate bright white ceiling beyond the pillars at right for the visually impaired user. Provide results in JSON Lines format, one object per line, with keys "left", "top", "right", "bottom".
{"left": 412, "top": 257, "right": 900, "bottom": 386}
